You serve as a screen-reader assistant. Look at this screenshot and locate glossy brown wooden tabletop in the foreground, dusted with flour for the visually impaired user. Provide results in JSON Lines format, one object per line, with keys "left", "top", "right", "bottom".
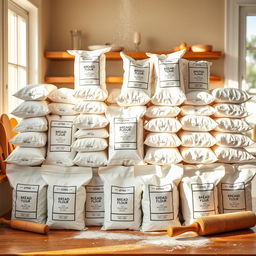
{"left": 0, "top": 226, "right": 256, "bottom": 256}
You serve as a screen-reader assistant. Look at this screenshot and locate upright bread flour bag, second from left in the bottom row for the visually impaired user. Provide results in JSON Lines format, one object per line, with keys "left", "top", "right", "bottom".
{"left": 41, "top": 165, "right": 92, "bottom": 230}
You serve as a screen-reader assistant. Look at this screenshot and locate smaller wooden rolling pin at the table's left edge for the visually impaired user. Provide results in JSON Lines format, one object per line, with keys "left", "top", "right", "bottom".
{"left": 0, "top": 218, "right": 49, "bottom": 234}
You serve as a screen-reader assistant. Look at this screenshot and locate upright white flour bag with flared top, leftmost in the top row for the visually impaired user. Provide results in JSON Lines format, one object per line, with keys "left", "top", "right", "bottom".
{"left": 68, "top": 47, "right": 111, "bottom": 101}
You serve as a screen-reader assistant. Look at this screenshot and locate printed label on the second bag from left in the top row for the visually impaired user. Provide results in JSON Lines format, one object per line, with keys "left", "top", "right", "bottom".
{"left": 127, "top": 62, "right": 150, "bottom": 89}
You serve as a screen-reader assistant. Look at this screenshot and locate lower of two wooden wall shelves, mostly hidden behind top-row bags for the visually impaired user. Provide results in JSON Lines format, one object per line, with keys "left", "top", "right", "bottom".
{"left": 45, "top": 76, "right": 222, "bottom": 84}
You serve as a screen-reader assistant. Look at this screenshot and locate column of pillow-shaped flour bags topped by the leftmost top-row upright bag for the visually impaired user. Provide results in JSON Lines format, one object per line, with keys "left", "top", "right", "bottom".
{"left": 68, "top": 48, "right": 110, "bottom": 167}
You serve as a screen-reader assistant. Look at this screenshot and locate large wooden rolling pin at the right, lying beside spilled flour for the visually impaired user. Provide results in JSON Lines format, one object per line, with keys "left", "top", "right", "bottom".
{"left": 167, "top": 211, "right": 256, "bottom": 237}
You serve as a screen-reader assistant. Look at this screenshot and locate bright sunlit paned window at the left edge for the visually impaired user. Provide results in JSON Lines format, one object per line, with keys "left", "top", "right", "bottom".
{"left": 7, "top": 1, "right": 28, "bottom": 111}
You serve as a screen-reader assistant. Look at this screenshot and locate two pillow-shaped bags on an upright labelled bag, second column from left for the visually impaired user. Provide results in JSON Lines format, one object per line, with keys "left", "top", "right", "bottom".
{"left": 45, "top": 88, "right": 77, "bottom": 166}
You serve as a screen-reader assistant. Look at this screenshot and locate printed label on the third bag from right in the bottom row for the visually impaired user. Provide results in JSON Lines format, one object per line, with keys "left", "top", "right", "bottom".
{"left": 148, "top": 184, "right": 174, "bottom": 221}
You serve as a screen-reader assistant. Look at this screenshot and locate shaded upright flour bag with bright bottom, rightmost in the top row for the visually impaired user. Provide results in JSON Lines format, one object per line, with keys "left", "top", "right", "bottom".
{"left": 181, "top": 59, "right": 214, "bottom": 105}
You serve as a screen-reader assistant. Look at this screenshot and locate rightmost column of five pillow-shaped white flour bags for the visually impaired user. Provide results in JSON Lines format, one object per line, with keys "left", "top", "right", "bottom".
{"left": 212, "top": 88, "right": 256, "bottom": 163}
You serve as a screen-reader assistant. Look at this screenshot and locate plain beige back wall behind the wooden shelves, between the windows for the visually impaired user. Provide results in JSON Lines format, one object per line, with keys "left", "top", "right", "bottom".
{"left": 45, "top": 0, "right": 224, "bottom": 87}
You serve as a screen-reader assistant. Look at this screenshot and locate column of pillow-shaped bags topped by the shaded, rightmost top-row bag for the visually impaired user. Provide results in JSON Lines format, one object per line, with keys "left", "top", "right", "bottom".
{"left": 179, "top": 59, "right": 217, "bottom": 164}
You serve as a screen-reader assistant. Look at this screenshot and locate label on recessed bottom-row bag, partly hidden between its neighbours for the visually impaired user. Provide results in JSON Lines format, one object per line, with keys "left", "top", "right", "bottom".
{"left": 85, "top": 185, "right": 104, "bottom": 219}
